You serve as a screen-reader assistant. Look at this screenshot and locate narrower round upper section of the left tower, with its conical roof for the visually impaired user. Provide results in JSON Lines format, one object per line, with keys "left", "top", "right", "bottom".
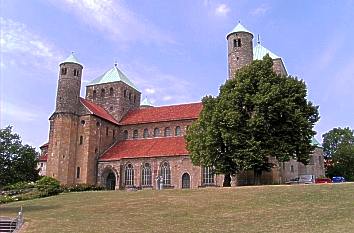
{"left": 55, "top": 53, "right": 83, "bottom": 114}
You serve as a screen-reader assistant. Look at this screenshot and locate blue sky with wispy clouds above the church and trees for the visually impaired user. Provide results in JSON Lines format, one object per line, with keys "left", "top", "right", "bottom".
{"left": 0, "top": 0, "right": 354, "bottom": 147}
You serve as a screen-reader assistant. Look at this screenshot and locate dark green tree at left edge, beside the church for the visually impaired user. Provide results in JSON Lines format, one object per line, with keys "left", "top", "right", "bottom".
{"left": 0, "top": 126, "right": 38, "bottom": 187}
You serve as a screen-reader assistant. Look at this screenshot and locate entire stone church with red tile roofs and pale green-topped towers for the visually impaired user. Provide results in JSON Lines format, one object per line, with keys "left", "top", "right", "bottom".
{"left": 38, "top": 23, "right": 324, "bottom": 189}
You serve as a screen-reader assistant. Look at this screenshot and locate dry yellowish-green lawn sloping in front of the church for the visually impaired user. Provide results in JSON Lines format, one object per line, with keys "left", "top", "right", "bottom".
{"left": 0, "top": 183, "right": 354, "bottom": 233}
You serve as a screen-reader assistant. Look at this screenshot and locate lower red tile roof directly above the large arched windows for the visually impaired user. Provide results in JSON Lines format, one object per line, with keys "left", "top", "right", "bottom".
{"left": 99, "top": 137, "right": 189, "bottom": 161}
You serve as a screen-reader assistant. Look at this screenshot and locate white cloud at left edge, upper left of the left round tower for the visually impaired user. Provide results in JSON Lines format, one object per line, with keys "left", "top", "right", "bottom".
{"left": 0, "top": 17, "right": 63, "bottom": 69}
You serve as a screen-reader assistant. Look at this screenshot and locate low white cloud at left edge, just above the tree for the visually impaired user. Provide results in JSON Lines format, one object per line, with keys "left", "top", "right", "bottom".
{"left": 0, "top": 101, "right": 39, "bottom": 122}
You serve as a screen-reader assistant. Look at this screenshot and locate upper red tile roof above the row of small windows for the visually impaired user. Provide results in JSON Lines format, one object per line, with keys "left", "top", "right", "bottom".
{"left": 119, "top": 103, "right": 203, "bottom": 125}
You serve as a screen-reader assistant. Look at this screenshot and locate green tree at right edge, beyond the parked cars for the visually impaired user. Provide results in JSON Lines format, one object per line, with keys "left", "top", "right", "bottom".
{"left": 322, "top": 127, "right": 354, "bottom": 180}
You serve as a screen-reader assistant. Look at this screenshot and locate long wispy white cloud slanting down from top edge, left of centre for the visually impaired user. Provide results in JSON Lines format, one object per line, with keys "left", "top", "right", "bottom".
{"left": 52, "top": 0, "right": 174, "bottom": 46}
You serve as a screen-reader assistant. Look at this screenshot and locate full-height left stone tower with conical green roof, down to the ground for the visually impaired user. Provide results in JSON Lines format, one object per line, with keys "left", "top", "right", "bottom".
{"left": 47, "top": 53, "right": 83, "bottom": 184}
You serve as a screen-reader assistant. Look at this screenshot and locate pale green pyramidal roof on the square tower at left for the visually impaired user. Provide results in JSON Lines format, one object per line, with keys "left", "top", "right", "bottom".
{"left": 87, "top": 65, "right": 138, "bottom": 90}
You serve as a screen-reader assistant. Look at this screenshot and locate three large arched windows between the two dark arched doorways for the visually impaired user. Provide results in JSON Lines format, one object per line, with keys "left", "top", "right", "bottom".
{"left": 124, "top": 162, "right": 171, "bottom": 186}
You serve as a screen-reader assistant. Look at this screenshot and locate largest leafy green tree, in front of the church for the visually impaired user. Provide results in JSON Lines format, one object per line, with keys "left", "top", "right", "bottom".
{"left": 186, "top": 55, "right": 319, "bottom": 186}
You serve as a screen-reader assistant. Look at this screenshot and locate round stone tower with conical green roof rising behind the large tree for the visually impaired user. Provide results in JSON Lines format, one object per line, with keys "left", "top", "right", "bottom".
{"left": 226, "top": 22, "right": 253, "bottom": 79}
